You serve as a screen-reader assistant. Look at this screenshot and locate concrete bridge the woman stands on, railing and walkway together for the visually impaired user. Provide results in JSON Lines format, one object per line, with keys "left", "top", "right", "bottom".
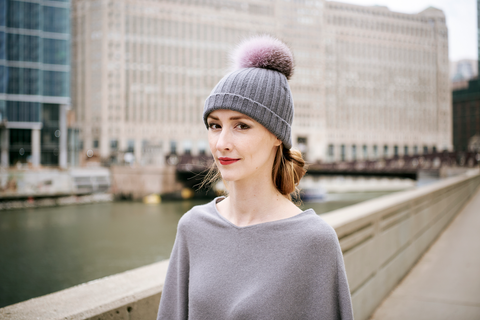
{"left": 0, "top": 168, "right": 480, "bottom": 320}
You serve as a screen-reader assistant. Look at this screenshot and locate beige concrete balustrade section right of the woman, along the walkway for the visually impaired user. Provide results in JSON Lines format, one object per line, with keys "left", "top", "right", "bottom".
{"left": 322, "top": 170, "right": 480, "bottom": 320}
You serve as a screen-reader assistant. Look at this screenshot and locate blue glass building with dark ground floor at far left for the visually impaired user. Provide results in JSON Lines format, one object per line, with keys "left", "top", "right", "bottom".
{"left": 0, "top": 0, "right": 70, "bottom": 167}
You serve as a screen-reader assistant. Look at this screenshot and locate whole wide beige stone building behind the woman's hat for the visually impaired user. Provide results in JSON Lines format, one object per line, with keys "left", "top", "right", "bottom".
{"left": 72, "top": 0, "right": 451, "bottom": 165}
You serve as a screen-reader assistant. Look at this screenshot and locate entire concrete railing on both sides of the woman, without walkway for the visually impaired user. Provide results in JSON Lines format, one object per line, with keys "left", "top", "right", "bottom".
{"left": 0, "top": 170, "right": 480, "bottom": 320}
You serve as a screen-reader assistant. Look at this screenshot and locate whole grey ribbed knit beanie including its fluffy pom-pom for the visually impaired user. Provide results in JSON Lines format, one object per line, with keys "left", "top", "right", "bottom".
{"left": 203, "top": 36, "right": 294, "bottom": 149}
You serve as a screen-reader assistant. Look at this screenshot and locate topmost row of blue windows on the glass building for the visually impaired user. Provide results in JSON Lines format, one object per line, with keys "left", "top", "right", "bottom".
{"left": 0, "top": 0, "right": 70, "bottom": 33}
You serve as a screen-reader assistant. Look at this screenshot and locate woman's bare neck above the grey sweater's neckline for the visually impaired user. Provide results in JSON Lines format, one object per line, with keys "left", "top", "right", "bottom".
{"left": 217, "top": 177, "right": 301, "bottom": 227}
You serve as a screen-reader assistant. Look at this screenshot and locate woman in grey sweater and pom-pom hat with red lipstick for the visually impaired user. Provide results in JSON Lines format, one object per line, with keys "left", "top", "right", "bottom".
{"left": 158, "top": 36, "right": 353, "bottom": 320}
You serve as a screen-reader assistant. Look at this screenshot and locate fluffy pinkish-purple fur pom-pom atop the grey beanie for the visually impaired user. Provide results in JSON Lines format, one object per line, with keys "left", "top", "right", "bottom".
{"left": 232, "top": 35, "right": 294, "bottom": 79}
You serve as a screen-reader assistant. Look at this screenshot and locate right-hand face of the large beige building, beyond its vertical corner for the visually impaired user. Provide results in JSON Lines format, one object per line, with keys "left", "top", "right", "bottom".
{"left": 324, "top": 2, "right": 452, "bottom": 161}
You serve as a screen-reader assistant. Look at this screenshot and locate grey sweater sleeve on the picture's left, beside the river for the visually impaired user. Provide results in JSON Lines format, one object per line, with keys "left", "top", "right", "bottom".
{"left": 157, "top": 220, "right": 190, "bottom": 320}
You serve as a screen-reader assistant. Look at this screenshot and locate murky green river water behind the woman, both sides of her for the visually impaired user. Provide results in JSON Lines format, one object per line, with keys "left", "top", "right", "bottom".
{"left": 0, "top": 192, "right": 394, "bottom": 308}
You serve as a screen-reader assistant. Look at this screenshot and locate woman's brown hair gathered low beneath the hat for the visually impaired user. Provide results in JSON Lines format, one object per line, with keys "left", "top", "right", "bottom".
{"left": 199, "top": 144, "right": 307, "bottom": 200}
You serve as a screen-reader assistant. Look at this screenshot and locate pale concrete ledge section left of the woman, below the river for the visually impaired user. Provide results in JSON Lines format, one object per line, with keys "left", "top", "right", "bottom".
{"left": 0, "top": 260, "right": 168, "bottom": 320}
